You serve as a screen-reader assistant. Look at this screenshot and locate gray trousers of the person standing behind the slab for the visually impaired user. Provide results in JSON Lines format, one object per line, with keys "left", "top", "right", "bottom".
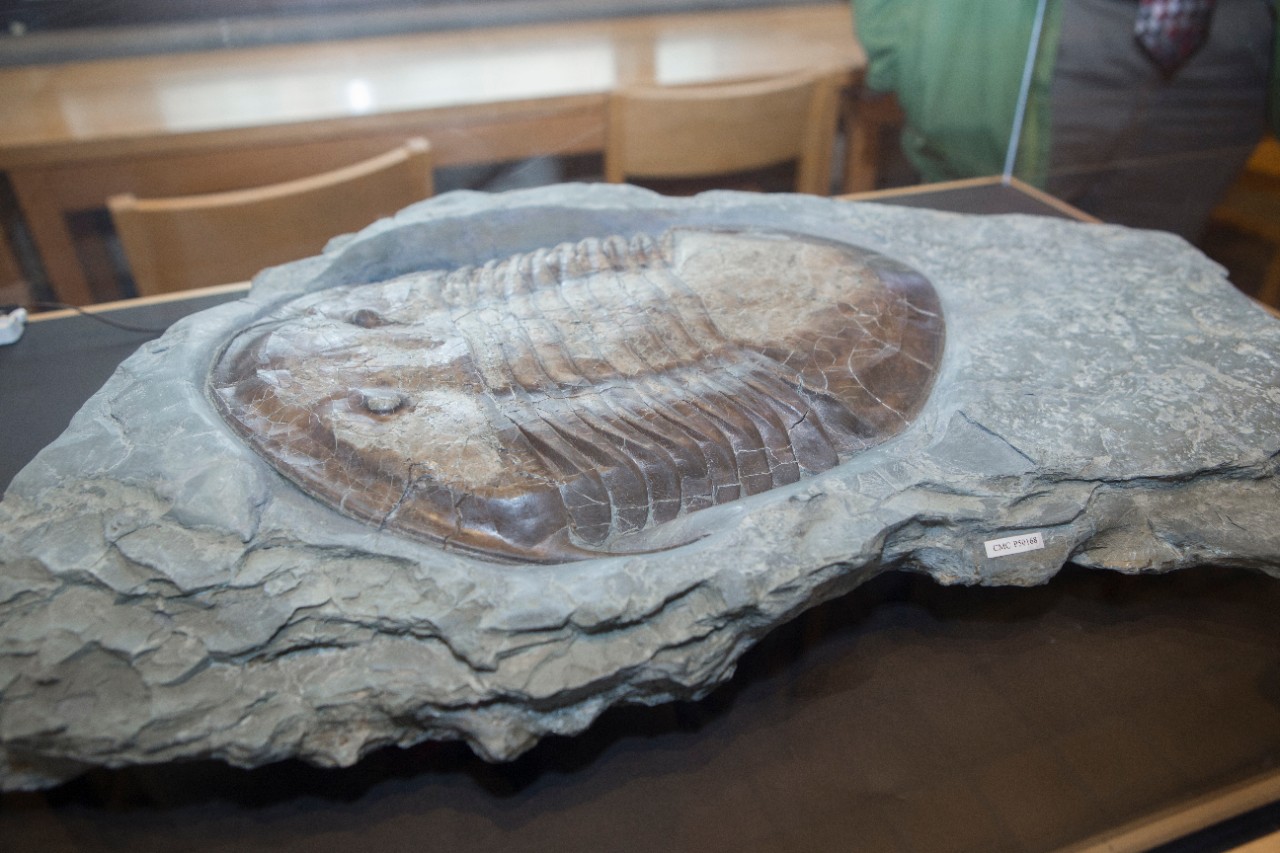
{"left": 1048, "top": 0, "right": 1275, "bottom": 241}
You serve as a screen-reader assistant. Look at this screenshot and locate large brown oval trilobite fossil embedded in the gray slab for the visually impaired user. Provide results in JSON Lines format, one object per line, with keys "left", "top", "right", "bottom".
{"left": 210, "top": 228, "right": 943, "bottom": 562}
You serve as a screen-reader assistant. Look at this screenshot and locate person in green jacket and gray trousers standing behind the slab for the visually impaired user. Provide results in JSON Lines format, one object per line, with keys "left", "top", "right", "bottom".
{"left": 851, "top": 0, "right": 1280, "bottom": 241}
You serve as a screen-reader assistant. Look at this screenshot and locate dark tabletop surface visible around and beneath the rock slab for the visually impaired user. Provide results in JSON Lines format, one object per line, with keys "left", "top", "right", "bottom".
{"left": 0, "top": 181, "right": 1280, "bottom": 853}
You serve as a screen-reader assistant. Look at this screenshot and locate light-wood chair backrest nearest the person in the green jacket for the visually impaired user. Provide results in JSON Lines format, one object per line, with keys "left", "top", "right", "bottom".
{"left": 604, "top": 72, "right": 846, "bottom": 195}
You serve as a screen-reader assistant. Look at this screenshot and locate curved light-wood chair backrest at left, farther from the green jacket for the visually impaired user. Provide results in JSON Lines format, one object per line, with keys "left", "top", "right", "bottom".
{"left": 108, "top": 138, "right": 434, "bottom": 296}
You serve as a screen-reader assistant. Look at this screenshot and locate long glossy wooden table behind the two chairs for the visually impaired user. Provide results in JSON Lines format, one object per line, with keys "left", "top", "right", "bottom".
{"left": 0, "top": 3, "right": 865, "bottom": 304}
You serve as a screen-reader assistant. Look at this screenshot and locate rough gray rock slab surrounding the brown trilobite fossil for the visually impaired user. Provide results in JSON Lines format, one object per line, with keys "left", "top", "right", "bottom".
{"left": 0, "top": 187, "right": 1280, "bottom": 788}
